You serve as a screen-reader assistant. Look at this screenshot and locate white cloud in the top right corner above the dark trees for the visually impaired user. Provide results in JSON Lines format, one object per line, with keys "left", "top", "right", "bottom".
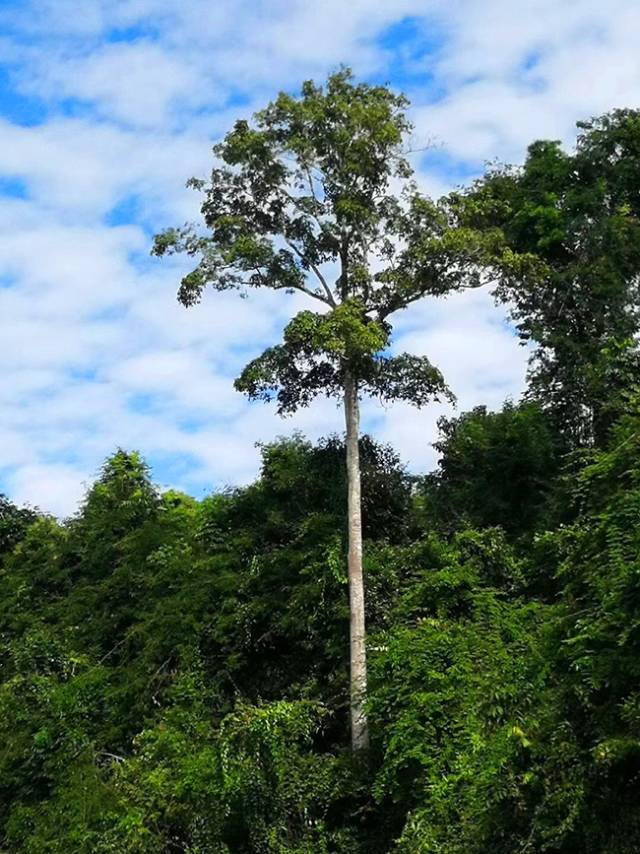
{"left": 413, "top": 0, "right": 640, "bottom": 162}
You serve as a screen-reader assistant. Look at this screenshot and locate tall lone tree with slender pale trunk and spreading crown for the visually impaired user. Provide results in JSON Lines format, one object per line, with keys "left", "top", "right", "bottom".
{"left": 153, "top": 69, "right": 495, "bottom": 751}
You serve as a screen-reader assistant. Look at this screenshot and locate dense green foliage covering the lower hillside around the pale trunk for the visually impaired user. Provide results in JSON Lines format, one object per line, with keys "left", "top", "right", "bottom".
{"left": 0, "top": 404, "right": 640, "bottom": 854}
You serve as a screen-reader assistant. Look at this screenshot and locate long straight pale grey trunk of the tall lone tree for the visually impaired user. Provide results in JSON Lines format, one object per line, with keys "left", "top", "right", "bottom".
{"left": 344, "top": 373, "right": 369, "bottom": 753}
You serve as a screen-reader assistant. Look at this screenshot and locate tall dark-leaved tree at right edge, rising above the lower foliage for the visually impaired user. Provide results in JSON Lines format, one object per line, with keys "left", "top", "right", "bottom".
{"left": 457, "top": 110, "right": 640, "bottom": 445}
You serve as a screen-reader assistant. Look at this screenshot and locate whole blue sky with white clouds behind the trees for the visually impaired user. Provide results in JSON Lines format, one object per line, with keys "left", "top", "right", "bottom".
{"left": 0, "top": 0, "right": 640, "bottom": 515}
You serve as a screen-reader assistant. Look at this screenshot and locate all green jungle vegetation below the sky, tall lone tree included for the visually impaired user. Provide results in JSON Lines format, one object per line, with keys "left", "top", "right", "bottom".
{"left": 0, "top": 77, "right": 640, "bottom": 854}
